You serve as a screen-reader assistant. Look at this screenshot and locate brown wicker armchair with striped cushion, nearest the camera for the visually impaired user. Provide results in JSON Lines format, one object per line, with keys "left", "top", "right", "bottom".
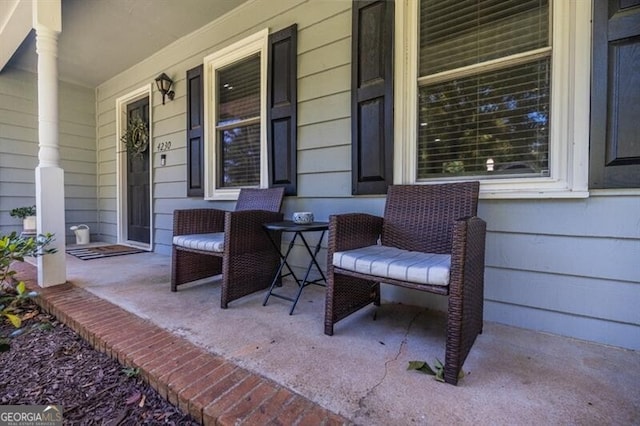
{"left": 325, "top": 182, "right": 486, "bottom": 385}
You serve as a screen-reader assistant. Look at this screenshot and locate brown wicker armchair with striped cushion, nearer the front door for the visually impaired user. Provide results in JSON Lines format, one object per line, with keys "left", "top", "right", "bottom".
{"left": 171, "top": 188, "right": 284, "bottom": 308}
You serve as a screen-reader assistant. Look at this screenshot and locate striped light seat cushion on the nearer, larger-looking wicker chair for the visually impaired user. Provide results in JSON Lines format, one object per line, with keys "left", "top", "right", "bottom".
{"left": 333, "top": 245, "right": 451, "bottom": 286}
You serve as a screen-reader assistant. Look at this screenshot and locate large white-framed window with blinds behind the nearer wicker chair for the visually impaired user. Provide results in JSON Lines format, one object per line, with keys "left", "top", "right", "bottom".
{"left": 394, "top": 0, "right": 590, "bottom": 197}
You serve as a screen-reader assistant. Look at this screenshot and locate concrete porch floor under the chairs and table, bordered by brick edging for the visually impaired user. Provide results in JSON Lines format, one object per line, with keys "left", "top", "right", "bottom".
{"left": 21, "top": 248, "right": 640, "bottom": 425}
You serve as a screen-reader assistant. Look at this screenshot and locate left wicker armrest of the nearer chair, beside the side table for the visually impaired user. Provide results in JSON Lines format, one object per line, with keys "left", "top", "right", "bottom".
{"left": 327, "top": 213, "right": 383, "bottom": 255}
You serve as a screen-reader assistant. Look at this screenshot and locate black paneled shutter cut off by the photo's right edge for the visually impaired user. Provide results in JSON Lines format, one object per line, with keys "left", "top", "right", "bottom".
{"left": 589, "top": 0, "right": 640, "bottom": 188}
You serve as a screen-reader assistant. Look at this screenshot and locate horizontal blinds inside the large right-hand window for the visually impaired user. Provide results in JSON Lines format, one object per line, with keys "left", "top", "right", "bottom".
{"left": 417, "top": 0, "right": 551, "bottom": 179}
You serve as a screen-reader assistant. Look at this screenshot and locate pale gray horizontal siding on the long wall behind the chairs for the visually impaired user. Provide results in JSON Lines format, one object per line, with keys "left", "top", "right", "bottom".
{"left": 97, "top": 0, "right": 640, "bottom": 349}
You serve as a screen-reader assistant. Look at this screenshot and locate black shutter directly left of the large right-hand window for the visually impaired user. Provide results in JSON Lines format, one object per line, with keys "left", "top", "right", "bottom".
{"left": 351, "top": 0, "right": 394, "bottom": 195}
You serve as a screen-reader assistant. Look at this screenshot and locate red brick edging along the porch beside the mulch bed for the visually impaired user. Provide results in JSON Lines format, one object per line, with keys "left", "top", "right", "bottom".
{"left": 14, "top": 263, "right": 349, "bottom": 425}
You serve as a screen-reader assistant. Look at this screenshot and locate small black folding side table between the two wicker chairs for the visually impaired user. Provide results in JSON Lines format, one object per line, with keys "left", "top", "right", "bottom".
{"left": 262, "top": 220, "right": 329, "bottom": 315}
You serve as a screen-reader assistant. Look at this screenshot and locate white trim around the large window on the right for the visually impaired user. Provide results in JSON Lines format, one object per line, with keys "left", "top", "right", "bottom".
{"left": 394, "top": 0, "right": 591, "bottom": 198}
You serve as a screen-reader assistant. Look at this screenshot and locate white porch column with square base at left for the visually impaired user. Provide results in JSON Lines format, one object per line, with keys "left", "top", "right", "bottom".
{"left": 33, "top": 0, "right": 67, "bottom": 287}
